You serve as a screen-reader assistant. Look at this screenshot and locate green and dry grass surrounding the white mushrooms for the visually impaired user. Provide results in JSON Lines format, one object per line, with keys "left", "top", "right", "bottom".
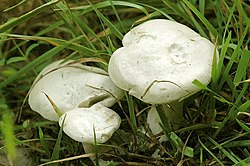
{"left": 0, "top": 0, "right": 250, "bottom": 166}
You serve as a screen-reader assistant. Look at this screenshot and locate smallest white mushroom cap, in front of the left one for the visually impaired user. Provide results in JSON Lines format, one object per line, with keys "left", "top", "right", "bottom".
{"left": 59, "top": 103, "right": 121, "bottom": 144}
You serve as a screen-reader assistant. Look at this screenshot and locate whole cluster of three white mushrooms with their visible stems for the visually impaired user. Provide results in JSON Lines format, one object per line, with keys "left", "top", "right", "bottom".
{"left": 29, "top": 19, "right": 218, "bottom": 161}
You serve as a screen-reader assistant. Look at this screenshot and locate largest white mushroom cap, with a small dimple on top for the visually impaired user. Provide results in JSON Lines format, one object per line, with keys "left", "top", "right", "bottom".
{"left": 109, "top": 19, "right": 218, "bottom": 104}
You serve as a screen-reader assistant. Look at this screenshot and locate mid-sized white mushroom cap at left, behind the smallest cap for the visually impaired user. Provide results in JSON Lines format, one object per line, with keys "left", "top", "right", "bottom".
{"left": 28, "top": 60, "right": 124, "bottom": 121}
